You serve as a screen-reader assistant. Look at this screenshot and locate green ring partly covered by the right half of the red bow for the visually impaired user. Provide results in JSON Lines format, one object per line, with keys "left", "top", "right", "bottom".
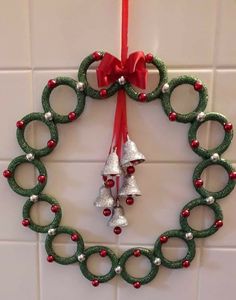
{"left": 124, "top": 57, "right": 168, "bottom": 102}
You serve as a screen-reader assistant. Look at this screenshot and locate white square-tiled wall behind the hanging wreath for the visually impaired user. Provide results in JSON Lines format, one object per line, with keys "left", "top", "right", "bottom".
{"left": 0, "top": 0, "right": 236, "bottom": 300}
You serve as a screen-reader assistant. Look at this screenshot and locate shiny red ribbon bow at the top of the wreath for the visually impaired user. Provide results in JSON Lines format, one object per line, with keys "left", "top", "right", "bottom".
{"left": 97, "top": 51, "right": 147, "bottom": 89}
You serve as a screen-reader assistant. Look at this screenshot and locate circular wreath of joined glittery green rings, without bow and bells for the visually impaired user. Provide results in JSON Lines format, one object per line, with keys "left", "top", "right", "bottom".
{"left": 4, "top": 51, "right": 235, "bottom": 285}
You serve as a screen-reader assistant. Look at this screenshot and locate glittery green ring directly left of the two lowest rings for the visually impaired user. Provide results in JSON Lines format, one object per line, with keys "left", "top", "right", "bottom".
{"left": 45, "top": 226, "right": 84, "bottom": 265}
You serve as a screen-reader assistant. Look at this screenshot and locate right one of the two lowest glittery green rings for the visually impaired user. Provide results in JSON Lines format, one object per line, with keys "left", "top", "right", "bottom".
{"left": 119, "top": 247, "right": 159, "bottom": 284}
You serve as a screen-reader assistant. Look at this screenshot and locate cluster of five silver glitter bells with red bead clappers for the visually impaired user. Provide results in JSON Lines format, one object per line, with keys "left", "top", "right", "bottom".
{"left": 94, "top": 137, "right": 145, "bottom": 234}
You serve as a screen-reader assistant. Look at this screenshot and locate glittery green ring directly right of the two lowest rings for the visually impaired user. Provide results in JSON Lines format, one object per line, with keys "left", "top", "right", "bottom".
{"left": 154, "top": 230, "right": 196, "bottom": 269}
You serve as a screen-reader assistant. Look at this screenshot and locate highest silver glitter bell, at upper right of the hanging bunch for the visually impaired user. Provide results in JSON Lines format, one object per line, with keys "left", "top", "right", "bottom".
{"left": 121, "top": 138, "right": 145, "bottom": 166}
